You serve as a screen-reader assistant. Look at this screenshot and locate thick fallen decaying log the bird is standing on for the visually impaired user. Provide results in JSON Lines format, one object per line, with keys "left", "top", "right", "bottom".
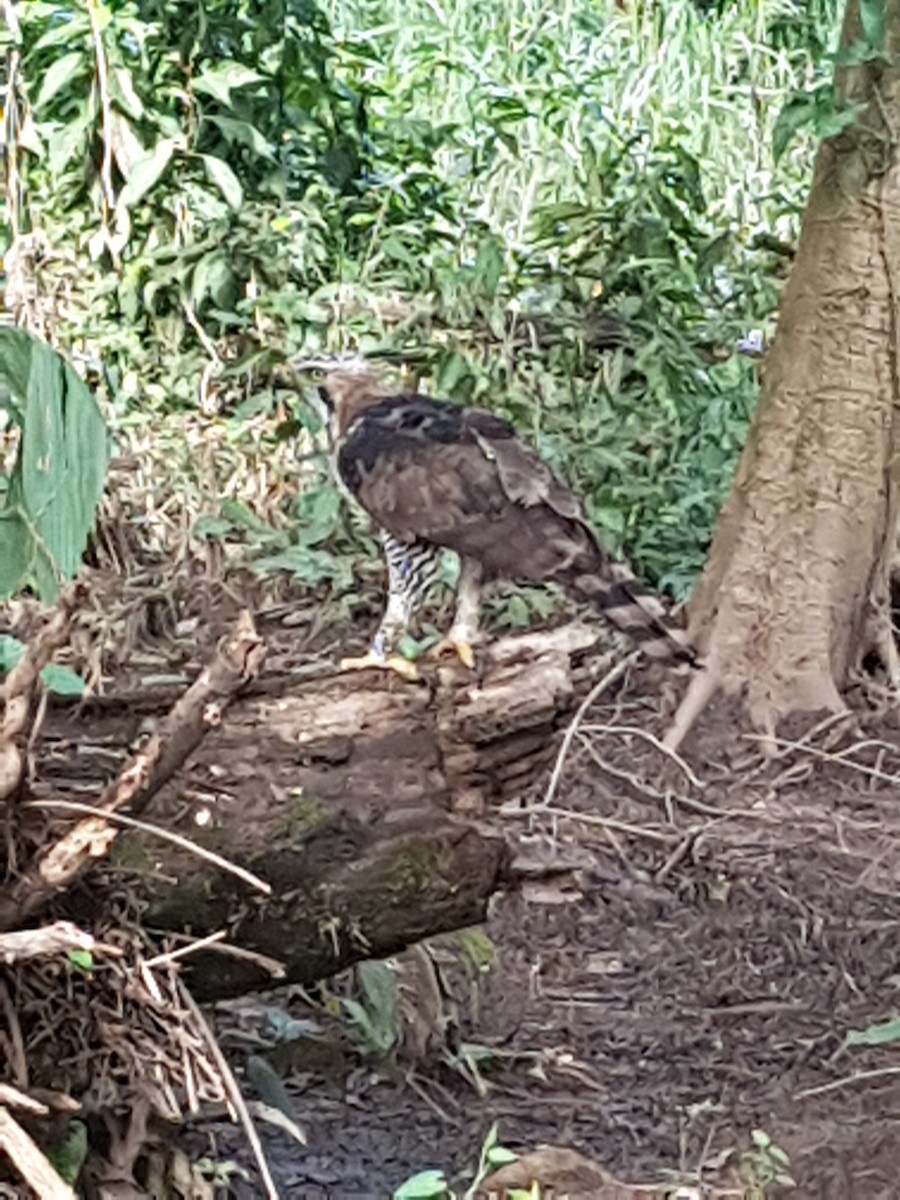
{"left": 41, "top": 625, "right": 604, "bottom": 998}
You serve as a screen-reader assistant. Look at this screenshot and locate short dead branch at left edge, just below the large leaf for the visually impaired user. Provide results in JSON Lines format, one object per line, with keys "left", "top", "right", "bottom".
{"left": 0, "top": 583, "right": 85, "bottom": 800}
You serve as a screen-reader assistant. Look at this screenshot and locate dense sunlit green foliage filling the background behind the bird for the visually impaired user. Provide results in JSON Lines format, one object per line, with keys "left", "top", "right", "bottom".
{"left": 8, "top": 0, "right": 844, "bottom": 600}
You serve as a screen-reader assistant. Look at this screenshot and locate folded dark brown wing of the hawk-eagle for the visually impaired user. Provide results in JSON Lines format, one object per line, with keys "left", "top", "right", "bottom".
{"left": 337, "top": 396, "right": 599, "bottom": 578}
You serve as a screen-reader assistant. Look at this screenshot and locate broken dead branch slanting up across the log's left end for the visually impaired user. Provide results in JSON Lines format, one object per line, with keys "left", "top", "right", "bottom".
{"left": 0, "top": 611, "right": 265, "bottom": 931}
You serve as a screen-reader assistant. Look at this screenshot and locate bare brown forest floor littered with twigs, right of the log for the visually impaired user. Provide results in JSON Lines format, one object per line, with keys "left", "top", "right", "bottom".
{"left": 164, "top": 585, "right": 900, "bottom": 1200}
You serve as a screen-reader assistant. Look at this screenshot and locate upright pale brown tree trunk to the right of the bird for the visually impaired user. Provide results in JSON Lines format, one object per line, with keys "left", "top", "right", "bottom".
{"left": 667, "top": 0, "right": 900, "bottom": 745}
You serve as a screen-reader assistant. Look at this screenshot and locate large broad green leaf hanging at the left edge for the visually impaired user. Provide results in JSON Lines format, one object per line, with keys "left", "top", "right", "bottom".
{"left": 0, "top": 328, "right": 108, "bottom": 600}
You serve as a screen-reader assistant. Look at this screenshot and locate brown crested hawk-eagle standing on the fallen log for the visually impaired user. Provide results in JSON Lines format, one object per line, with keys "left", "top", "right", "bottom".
{"left": 301, "top": 360, "right": 692, "bottom": 676}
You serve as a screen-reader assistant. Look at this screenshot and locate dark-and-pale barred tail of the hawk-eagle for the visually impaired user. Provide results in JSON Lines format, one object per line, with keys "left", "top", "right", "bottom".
{"left": 559, "top": 562, "right": 696, "bottom": 662}
